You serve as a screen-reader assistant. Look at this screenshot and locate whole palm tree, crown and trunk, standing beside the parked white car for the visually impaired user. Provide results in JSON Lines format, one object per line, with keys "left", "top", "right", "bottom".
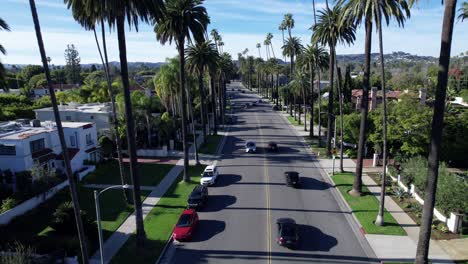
{"left": 154, "top": 0, "right": 210, "bottom": 182}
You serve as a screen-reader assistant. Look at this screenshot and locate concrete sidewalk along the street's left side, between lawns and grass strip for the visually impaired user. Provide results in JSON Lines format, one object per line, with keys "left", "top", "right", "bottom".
{"left": 90, "top": 135, "right": 216, "bottom": 264}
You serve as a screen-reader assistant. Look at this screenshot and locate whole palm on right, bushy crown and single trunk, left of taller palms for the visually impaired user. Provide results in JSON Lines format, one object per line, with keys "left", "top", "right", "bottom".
{"left": 312, "top": 4, "right": 356, "bottom": 156}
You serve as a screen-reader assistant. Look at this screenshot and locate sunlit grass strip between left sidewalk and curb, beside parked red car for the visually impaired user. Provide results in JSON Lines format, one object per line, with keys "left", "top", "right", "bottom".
{"left": 112, "top": 166, "right": 205, "bottom": 264}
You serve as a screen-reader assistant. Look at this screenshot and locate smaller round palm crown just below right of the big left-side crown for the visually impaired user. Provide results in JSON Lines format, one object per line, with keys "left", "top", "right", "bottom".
{"left": 185, "top": 40, "right": 219, "bottom": 74}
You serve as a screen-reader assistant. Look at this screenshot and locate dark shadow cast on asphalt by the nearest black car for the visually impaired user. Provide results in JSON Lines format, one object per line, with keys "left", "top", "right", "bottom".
{"left": 298, "top": 225, "right": 338, "bottom": 252}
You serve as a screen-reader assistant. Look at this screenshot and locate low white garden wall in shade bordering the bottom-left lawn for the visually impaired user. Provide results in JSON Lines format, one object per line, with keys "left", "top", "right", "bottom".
{"left": 0, "top": 166, "right": 96, "bottom": 225}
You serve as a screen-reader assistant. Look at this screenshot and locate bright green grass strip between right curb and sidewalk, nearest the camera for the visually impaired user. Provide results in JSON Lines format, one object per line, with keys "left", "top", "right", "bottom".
{"left": 332, "top": 173, "right": 406, "bottom": 236}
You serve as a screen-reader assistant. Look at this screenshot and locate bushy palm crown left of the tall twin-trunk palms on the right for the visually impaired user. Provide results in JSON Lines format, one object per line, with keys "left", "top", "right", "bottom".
{"left": 311, "top": 4, "right": 356, "bottom": 48}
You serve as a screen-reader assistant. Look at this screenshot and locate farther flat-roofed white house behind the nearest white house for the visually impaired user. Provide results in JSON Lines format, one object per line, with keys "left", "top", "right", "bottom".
{"left": 34, "top": 103, "right": 112, "bottom": 134}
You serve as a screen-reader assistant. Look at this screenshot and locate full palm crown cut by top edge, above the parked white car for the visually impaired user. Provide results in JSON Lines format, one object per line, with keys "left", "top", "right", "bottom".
{"left": 154, "top": 0, "right": 210, "bottom": 45}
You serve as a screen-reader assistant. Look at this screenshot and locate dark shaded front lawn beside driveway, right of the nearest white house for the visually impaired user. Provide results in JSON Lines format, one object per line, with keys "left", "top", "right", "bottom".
{"left": 83, "top": 161, "right": 174, "bottom": 186}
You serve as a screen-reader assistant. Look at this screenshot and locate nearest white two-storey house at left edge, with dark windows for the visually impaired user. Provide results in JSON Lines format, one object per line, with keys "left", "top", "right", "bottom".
{"left": 0, "top": 120, "right": 100, "bottom": 172}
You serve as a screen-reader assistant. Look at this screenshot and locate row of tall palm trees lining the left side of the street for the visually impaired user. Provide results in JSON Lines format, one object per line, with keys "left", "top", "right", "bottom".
{"left": 29, "top": 0, "right": 231, "bottom": 263}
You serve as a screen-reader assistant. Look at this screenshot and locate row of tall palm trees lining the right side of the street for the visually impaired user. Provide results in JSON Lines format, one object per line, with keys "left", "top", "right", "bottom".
{"left": 247, "top": 0, "right": 462, "bottom": 263}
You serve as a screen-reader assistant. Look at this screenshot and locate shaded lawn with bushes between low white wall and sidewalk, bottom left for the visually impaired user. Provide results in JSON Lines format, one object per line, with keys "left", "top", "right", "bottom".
{"left": 0, "top": 185, "right": 149, "bottom": 256}
